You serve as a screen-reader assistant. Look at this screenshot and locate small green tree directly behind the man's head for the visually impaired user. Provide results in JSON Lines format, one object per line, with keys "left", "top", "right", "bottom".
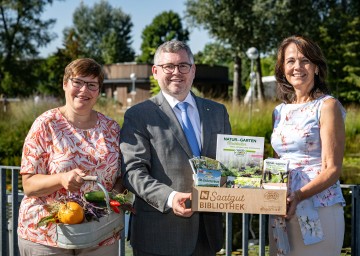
{"left": 137, "top": 11, "right": 189, "bottom": 64}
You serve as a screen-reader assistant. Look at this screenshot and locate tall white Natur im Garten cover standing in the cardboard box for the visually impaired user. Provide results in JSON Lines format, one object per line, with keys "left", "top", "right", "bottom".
{"left": 216, "top": 134, "right": 265, "bottom": 187}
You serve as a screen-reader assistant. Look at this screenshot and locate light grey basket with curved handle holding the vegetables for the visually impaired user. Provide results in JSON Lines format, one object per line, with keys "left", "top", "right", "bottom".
{"left": 56, "top": 178, "right": 125, "bottom": 249}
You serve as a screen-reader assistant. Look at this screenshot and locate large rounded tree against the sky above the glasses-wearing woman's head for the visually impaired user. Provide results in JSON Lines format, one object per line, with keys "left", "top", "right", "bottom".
{"left": 64, "top": 1, "right": 135, "bottom": 64}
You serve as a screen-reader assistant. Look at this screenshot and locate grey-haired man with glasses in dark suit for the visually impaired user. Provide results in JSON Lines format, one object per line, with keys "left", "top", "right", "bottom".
{"left": 120, "top": 41, "right": 231, "bottom": 256}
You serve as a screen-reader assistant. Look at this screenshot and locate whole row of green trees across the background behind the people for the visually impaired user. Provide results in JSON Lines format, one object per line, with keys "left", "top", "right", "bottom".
{"left": 0, "top": 0, "right": 360, "bottom": 104}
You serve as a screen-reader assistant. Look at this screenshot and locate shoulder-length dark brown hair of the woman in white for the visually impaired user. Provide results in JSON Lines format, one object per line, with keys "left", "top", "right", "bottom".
{"left": 275, "top": 36, "right": 329, "bottom": 103}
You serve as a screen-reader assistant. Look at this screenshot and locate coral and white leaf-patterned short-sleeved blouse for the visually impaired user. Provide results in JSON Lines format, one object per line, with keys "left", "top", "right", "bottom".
{"left": 18, "top": 108, "right": 120, "bottom": 247}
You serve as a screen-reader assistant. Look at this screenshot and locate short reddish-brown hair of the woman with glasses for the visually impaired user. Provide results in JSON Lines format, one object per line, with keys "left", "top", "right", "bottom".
{"left": 63, "top": 58, "right": 105, "bottom": 91}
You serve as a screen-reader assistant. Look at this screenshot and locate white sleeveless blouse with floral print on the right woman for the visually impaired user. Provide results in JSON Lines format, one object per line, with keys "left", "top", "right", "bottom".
{"left": 271, "top": 95, "right": 346, "bottom": 247}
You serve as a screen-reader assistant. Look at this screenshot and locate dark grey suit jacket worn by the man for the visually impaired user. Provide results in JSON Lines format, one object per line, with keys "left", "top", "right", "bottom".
{"left": 120, "top": 93, "right": 231, "bottom": 255}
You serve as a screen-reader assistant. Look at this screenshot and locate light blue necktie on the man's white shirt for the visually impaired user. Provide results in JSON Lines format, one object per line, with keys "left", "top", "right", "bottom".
{"left": 176, "top": 102, "right": 200, "bottom": 156}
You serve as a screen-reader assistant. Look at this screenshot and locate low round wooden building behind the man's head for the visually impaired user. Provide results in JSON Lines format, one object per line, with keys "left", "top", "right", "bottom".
{"left": 103, "top": 63, "right": 232, "bottom": 108}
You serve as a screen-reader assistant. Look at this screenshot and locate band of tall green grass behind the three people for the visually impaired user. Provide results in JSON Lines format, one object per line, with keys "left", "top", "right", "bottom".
{"left": 0, "top": 98, "right": 360, "bottom": 184}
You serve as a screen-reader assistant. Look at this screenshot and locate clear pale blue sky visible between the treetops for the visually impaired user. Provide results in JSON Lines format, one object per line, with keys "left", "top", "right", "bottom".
{"left": 40, "top": 0, "right": 212, "bottom": 57}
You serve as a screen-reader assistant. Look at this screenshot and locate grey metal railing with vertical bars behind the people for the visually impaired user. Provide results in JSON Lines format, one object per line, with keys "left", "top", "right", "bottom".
{"left": 0, "top": 166, "right": 360, "bottom": 256}
